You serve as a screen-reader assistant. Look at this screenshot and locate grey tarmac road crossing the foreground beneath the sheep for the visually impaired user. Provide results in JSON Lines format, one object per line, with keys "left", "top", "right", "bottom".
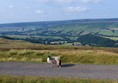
{"left": 0, "top": 62, "right": 118, "bottom": 80}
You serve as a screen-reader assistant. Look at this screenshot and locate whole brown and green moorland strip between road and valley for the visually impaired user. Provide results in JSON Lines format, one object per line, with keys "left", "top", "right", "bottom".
{"left": 0, "top": 38, "right": 118, "bottom": 64}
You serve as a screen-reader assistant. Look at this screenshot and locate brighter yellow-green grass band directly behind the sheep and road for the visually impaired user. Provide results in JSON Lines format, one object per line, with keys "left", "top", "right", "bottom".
{"left": 0, "top": 49, "right": 118, "bottom": 64}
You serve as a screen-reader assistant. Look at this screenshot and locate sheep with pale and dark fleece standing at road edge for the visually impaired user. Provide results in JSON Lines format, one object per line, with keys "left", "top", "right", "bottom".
{"left": 47, "top": 56, "right": 61, "bottom": 67}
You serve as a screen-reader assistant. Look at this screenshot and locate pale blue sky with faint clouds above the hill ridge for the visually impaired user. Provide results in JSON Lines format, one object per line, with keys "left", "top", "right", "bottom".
{"left": 0, "top": 0, "right": 118, "bottom": 24}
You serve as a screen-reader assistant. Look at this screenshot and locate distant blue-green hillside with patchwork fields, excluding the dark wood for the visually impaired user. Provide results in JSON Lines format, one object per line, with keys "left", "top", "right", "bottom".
{"left": 0, "top": 19, "right": 118, "bottom": 47}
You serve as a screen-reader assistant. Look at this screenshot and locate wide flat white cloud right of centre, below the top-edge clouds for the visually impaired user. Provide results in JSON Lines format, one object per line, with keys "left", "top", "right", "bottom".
{"left": 65, "top": 6, "right": 89, "bottom": 13}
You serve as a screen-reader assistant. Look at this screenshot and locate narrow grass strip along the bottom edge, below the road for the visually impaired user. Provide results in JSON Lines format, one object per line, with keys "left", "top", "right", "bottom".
{"left": 0, "top": 76, "right": 118, "bottom": 83}
